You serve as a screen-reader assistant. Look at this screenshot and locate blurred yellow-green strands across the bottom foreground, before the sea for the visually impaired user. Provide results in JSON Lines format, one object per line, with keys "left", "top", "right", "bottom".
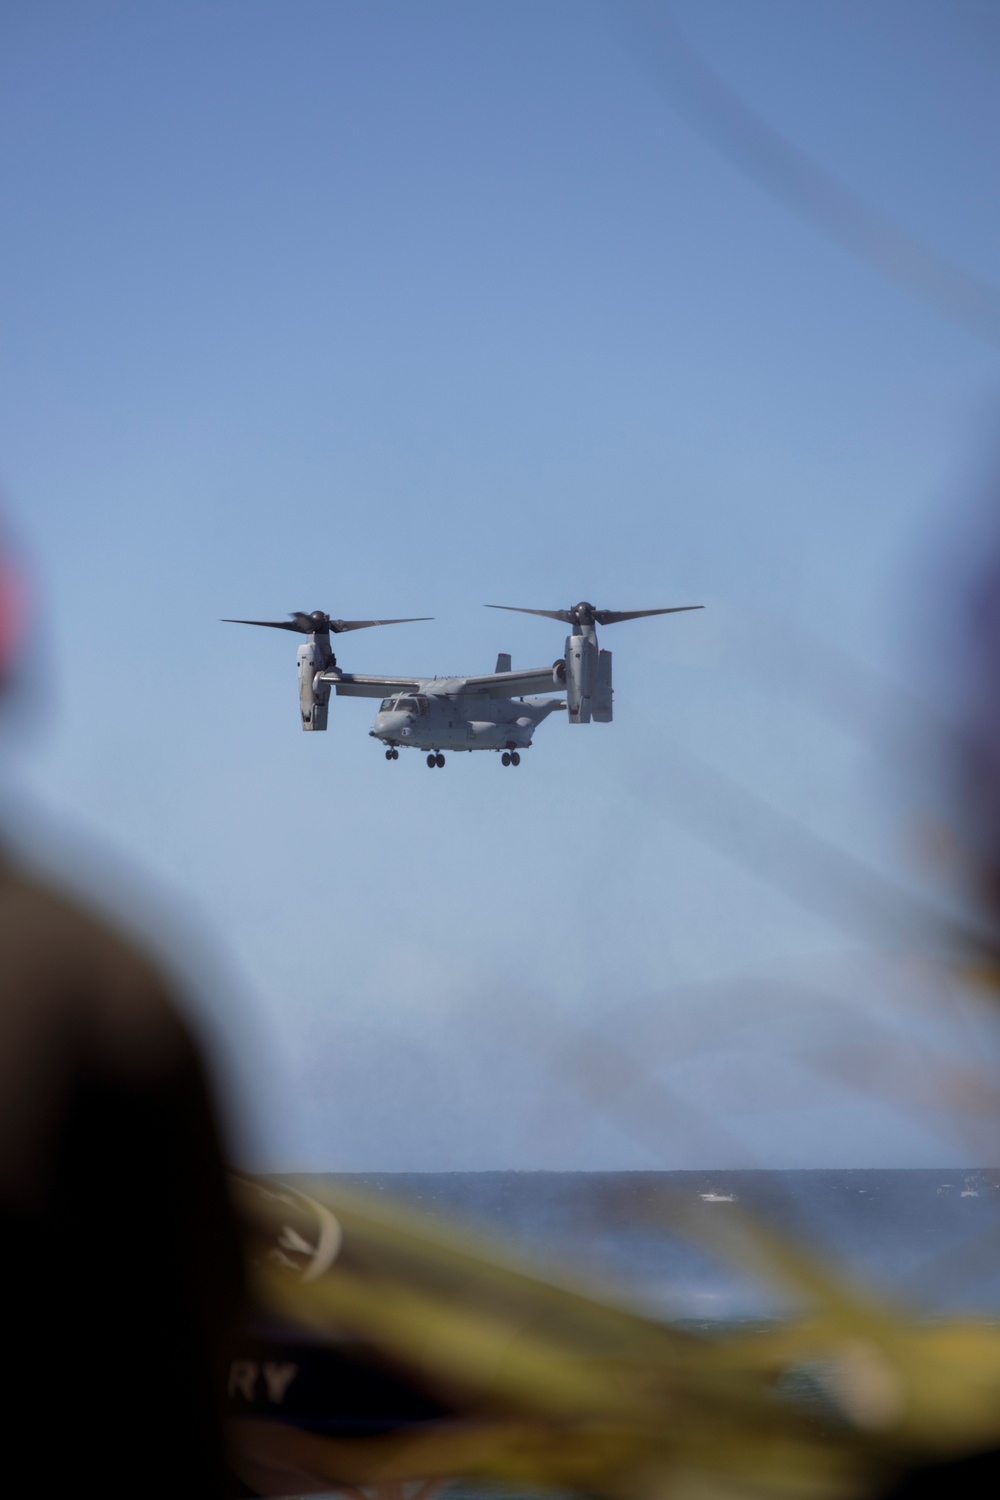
{"left": 229, "top": 1181, "right": 1000, "bottom": 1500}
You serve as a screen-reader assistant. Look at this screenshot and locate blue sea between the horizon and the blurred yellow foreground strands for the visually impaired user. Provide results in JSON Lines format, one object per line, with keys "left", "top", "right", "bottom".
{"left": 312, "top": 1167, "right": 1000, "bottom": 1323}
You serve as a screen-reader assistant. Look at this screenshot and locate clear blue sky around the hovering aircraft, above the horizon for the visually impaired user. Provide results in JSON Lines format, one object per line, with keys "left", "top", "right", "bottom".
{"left": 0, "top": 0, "right": 1000, "bottom": 1169}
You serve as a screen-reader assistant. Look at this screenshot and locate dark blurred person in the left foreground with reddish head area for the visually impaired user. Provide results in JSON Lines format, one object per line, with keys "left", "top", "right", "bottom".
{"left": 0, "top": 543, "right": 241, "bottom": 1500}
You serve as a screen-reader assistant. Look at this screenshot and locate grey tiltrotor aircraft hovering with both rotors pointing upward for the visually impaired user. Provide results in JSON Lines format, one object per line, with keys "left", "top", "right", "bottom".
{"left": 225, "top": 603, "right": 703, "bottom": 767}
